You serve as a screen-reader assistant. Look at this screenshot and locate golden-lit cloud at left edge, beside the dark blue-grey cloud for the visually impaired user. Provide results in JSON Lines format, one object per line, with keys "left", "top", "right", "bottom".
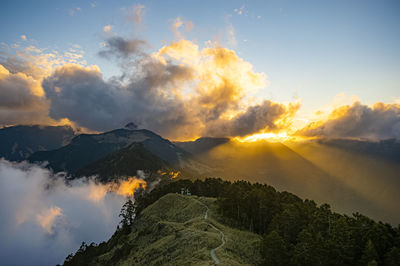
{"left": 0, "top": 40, "right": 90, "bottom": 128}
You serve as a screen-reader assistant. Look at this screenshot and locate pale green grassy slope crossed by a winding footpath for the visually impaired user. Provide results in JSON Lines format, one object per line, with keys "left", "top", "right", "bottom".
{"left": 96, "top": 194, "right": 261, "bottom": 265}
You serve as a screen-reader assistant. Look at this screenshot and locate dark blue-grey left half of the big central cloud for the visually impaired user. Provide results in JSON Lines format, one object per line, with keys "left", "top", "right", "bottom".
{"left": 43, "top": 56, "right": 195, "bottom": 133}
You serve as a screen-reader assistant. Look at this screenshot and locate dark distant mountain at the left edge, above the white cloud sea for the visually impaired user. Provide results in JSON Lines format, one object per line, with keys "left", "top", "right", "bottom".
{"left": 0, "top": 125, "right": 74, "bottom": 161}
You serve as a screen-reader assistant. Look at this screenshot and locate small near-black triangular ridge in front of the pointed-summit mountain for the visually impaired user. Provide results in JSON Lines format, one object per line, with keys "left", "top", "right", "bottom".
{"left": 76, "top": 142, "right": 169, "bottom": 182}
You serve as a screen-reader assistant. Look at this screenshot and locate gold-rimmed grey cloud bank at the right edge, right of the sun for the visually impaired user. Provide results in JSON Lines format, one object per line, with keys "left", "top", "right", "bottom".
{"left": 297, "top": 102, "right": 400, "bottom": 139}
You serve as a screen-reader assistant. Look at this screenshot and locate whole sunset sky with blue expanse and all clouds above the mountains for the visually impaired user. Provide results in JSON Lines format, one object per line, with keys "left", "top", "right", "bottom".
{"left": 0, "top": 1, "right": 400, "bottom": 139}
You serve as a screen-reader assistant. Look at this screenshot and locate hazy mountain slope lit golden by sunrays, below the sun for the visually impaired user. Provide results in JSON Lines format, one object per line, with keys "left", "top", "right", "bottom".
{"left": 180, "top": 137, "right": 400, "bottom": 223}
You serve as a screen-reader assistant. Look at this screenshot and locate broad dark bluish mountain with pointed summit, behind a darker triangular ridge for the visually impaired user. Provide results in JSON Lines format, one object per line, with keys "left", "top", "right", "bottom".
{"left": 29, "top": 128, "right": 187, "bottom": 174}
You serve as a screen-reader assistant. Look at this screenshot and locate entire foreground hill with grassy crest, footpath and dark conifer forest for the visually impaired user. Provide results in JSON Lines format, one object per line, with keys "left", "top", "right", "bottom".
{"left": 65, "top": 179, "right": 400, "bottom": 266}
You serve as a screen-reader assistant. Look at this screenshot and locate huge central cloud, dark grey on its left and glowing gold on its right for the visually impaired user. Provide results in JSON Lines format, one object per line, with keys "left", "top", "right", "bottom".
{"left": 43, "top": 37, "right": 290, "bottom": 139}
